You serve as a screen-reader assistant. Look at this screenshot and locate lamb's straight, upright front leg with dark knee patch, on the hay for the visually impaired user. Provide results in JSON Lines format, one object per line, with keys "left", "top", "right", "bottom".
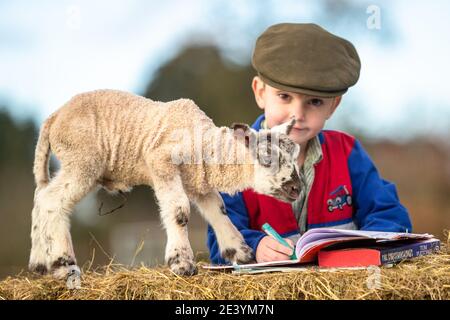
{"left": 153, "top": 175, "right": 197, "bottom": 276}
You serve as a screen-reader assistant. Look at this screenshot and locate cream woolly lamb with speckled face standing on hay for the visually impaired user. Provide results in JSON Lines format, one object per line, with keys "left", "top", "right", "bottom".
{"left": 29, "top": 90, "right": 303, "bottom": 280}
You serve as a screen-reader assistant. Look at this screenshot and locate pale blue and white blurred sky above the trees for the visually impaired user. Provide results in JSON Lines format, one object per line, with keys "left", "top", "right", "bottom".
{"left": 0, "top": 0, "right": 450, "bottom": 139}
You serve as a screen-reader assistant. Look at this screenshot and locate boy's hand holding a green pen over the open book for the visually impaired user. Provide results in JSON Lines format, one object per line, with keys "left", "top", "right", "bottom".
{"left": 256, "top": 236, "right": 294, "bottom": 262}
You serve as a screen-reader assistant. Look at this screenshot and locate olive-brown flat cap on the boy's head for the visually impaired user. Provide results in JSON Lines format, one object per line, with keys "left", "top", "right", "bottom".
{"left": 252, "top": 23, "right": 361, "bottom": 97}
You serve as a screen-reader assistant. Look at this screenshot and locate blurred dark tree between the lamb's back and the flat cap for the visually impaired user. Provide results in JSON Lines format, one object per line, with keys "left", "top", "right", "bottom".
{"left": 144, "top": 45, "right": 262, "bottom": 126}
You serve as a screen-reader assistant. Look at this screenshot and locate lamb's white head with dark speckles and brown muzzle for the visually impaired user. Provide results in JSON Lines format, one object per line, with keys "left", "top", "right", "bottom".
{"left": 232, "top": 120, "right": 304, "bottom": 202}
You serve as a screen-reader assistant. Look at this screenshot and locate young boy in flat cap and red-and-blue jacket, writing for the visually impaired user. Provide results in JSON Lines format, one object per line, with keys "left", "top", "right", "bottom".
{"left": 207, "top": 23, "right": 411, "bottom": 264}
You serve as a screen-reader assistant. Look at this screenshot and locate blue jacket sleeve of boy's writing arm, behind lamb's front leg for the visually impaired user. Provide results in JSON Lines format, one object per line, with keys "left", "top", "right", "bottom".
{"left": 206, "top": 192, "right": 266, "bottom": 264}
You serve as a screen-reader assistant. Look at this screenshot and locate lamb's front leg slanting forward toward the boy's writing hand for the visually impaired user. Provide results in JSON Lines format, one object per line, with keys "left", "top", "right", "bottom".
{"left": 196, "top": 192, "right": 255, "bottom": 264}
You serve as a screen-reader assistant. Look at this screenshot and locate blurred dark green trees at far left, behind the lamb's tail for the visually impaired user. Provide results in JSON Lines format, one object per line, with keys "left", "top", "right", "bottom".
{"left": 0, "top": 108, "right": 37, "bottom": 277}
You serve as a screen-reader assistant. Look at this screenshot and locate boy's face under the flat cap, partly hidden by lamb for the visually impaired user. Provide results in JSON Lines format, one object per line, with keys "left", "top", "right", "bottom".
{"left": 252, "top": 77, "right": 342, "bottom": 150}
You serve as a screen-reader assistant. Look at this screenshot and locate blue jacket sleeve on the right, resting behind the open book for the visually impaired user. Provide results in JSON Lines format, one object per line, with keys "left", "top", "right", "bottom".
{"left": 348, "top": 140, "right": 412, "bottom": 232}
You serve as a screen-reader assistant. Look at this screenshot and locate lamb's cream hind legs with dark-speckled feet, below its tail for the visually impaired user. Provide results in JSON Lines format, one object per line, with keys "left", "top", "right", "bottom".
{"left": 29, "top": 168, "right": 97, "bottom": 286}
